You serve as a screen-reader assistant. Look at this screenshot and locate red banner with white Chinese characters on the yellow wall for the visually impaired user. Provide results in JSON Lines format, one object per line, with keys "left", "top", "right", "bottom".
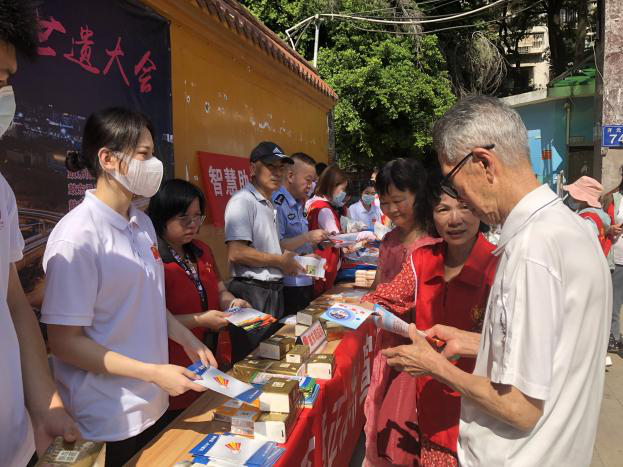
{"left": 197, "top": 151, "right": 249, "bottom": 227}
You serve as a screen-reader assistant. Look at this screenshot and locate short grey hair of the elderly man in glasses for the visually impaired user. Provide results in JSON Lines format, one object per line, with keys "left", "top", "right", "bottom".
{"left": 433, "top": 95, "right": 530, "bottom": 166}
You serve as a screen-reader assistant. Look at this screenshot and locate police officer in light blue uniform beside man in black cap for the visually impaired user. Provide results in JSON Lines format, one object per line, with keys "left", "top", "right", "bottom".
{"left": 273, "top": 152, "right": 329, "bottom": 314}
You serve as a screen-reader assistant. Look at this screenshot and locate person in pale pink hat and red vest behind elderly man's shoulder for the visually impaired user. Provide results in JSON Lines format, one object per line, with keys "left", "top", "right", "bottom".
{"left": 563, "top": 176, "right": 610, "bottom": 255}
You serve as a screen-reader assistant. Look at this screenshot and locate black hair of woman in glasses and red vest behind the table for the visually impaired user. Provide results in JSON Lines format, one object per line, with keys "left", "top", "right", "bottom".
{"left": 147, "top": 178, "right": 205, "bottom": 237}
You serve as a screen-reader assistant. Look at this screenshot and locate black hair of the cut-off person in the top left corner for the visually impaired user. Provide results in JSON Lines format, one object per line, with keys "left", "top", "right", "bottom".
{"left": 0, "top": 0, "right": 38, "bottom": 58}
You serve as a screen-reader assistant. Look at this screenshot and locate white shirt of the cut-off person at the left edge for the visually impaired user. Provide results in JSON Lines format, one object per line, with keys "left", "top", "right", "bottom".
{"left": 0, "top": 175, "right": 35, "bottom": 467}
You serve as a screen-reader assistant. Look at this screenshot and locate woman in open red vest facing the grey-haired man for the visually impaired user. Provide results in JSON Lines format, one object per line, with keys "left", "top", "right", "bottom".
{"left": 364, "top": 182, "right": 497, "bottom": 466}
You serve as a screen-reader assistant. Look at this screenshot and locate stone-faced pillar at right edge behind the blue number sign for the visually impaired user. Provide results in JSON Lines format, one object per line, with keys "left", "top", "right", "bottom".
{"left": 593, "top": 0, "right": 623, "bottom": 190}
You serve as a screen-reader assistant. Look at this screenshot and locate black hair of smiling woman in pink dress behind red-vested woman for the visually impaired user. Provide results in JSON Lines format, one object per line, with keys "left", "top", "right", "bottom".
{"left": 376, "top": 157, "right": 432, "bottom": 231}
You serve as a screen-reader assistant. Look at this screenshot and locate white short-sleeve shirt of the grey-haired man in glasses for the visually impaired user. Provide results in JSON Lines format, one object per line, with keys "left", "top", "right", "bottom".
{"left": 458, "top": 185, "right": 612, "bottom": 467}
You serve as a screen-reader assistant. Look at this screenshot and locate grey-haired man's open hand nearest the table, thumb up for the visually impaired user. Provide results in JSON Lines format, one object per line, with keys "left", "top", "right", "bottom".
{"left": 382, "top": 323, "right": 445, "bottom": 376}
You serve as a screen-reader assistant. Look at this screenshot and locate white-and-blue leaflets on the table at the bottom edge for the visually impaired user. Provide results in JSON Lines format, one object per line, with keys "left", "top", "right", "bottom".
{"left": 190, "top": 434, "right": 285, "bottom": 467}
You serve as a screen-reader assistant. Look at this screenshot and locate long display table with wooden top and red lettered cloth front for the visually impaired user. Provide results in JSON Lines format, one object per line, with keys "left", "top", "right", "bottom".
{"left": 126, "top": 286, "right": 376, "bottom": 467}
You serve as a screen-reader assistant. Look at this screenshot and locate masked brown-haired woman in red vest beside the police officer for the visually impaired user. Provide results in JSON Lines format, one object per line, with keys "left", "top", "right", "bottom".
{"left": 305, "top": 164, "right": 348, "bottom": 297}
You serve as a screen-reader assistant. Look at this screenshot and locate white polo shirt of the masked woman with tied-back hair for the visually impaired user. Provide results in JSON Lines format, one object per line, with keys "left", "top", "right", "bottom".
{"left": 41, "top": 191, "right": 169, "bottom": 441}
